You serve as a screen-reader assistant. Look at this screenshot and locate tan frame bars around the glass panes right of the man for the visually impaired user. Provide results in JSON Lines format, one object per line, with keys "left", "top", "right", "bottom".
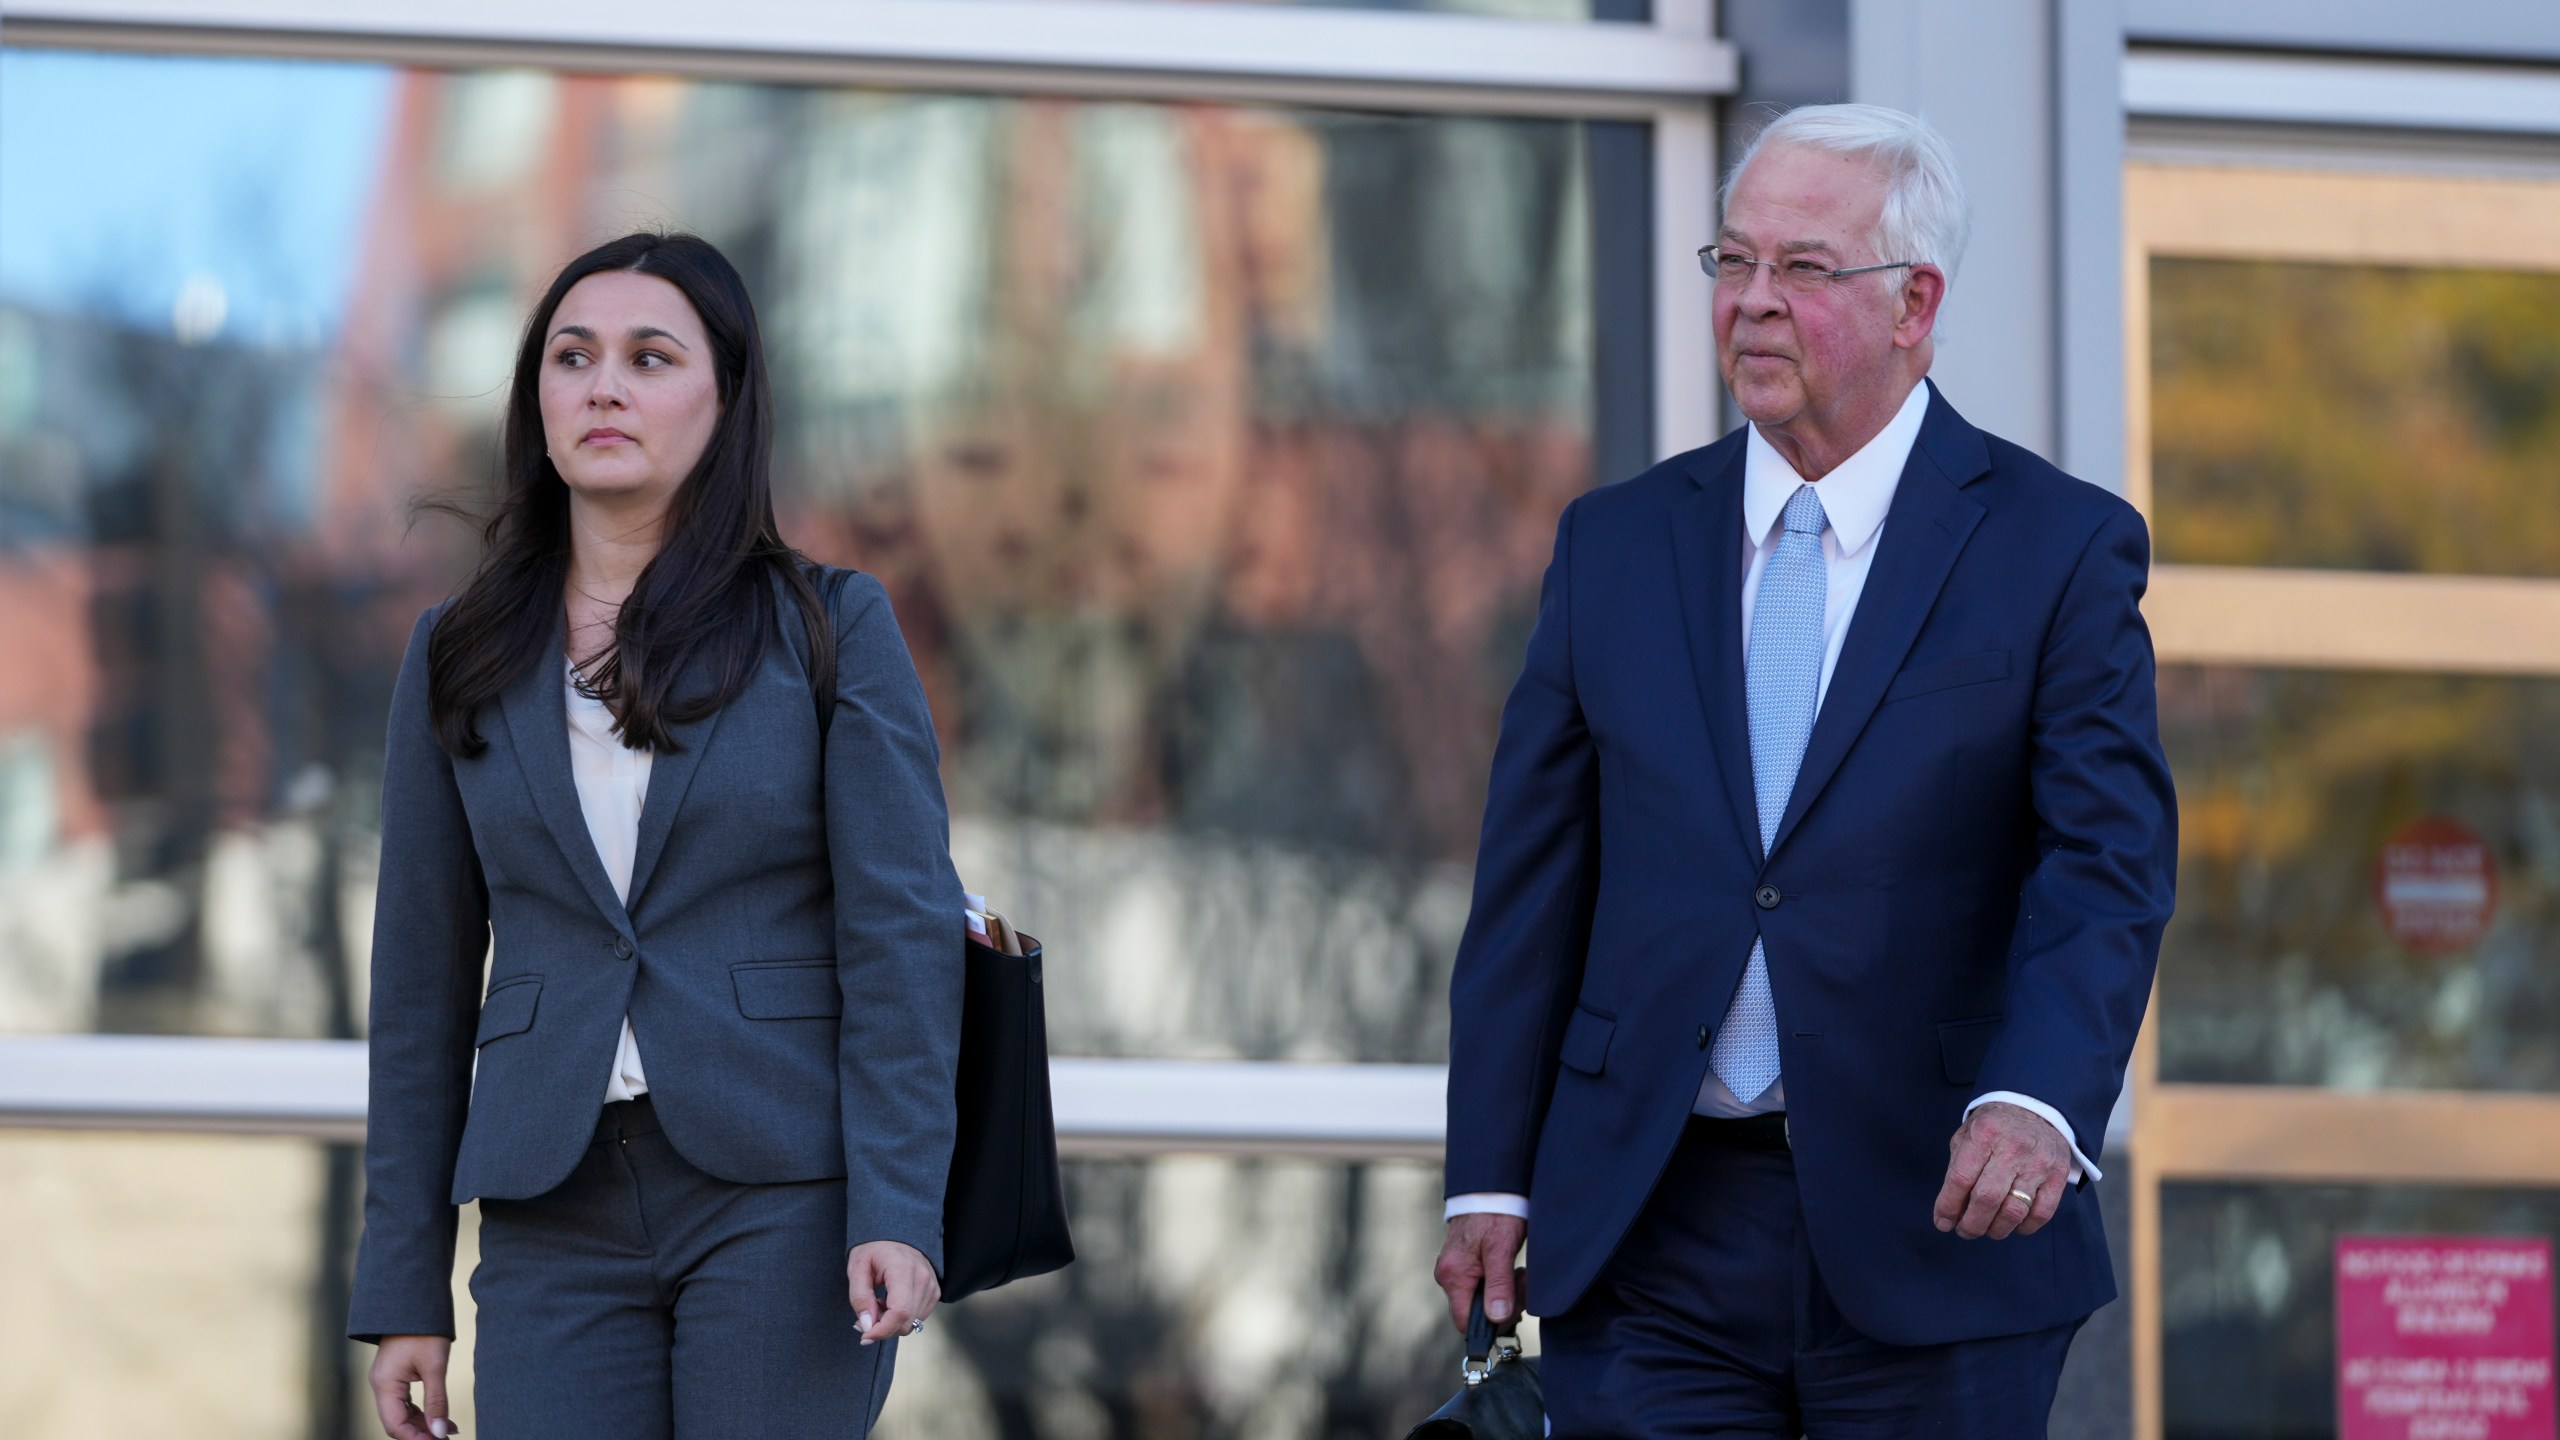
{"left": 2125, "top": 159, "right": 2560, "bottom": 1440}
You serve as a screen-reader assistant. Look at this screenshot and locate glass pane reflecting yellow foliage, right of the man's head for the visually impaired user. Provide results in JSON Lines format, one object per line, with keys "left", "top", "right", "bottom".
{"left": 2150, "top": 256, "right": 2560, "bottom": 577}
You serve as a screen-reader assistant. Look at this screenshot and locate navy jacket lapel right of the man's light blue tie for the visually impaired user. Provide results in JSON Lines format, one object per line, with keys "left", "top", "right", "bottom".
{"left": 1769, "top": 384, "right": 1992, "bottom": 856}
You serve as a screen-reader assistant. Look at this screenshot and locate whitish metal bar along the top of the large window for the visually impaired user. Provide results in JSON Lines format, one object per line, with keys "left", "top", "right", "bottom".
{"left": 5, "top": 0, "right": 1736, "bottom": 118}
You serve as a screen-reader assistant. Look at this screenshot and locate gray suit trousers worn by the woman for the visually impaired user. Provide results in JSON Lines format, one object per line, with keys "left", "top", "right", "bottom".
{"left": 471, "top": 1097, "right": 896, "bottom": 1440}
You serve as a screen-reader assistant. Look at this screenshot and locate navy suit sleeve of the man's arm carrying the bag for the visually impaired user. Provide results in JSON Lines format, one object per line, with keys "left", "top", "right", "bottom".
{"left": 1441, "top": 502, "right": 1600, "bottom": 1197}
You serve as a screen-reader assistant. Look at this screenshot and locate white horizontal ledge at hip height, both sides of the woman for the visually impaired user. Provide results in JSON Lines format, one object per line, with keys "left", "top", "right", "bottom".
{"left": 0, "top": 1035, "right": 1449, "bottom": 1158}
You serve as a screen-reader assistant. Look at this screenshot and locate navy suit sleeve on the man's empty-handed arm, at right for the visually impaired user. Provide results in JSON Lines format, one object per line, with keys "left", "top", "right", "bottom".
{"left": 1979, "top": 507, "right": 2179, "bottom": 1143}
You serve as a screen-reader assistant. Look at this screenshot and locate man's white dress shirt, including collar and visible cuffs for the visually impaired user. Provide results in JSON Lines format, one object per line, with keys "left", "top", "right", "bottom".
{"left": 1446, "top": 384, "right": 2099, "bottom": 1217}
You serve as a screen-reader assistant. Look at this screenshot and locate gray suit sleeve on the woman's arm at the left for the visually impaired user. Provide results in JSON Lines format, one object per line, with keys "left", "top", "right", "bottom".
{"left": 348, "top": 610, "right": 489, "bottom": 1343}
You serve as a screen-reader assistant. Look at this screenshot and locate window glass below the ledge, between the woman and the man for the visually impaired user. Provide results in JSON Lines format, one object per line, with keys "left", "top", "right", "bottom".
{"left": 885, "top": 1156, "right": 1474, "bottom": 1440}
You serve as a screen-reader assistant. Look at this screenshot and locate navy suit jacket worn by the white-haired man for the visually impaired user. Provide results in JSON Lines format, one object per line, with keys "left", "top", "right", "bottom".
{"left": 1446, "top": 389, "right": 2176, "bottom": 1345}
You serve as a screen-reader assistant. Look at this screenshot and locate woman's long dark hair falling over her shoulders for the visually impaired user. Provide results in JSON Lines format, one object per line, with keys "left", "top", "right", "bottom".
{"left": 428, "top": 233, "right": 835, "bottom": 756}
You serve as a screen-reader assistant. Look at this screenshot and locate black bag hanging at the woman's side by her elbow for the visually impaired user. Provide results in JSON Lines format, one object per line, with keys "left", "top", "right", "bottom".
{"left": 942, "top": 935, "right": 1075, "bottom": 1299}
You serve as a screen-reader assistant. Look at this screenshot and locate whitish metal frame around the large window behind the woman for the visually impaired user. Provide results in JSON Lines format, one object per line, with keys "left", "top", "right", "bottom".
{"left": 0, "top": 0, "right": 1738, "bottom": 1161}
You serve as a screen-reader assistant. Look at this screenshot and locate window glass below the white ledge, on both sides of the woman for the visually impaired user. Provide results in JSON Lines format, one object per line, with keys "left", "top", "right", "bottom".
{"left": 0, "top": 1133, "right": 1464, "bottom": 1440}
